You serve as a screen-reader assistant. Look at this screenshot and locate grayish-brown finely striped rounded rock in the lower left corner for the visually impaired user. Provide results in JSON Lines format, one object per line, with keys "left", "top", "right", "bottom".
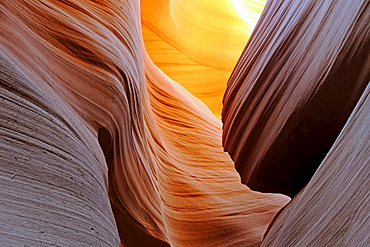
{"left": 0, "top": 49, "right": 120, "bottom": 246}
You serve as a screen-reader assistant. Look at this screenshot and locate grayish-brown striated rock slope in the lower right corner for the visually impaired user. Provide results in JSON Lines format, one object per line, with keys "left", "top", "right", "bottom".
{"left": 262, "top": 85, "right": 370, "bottom": 246}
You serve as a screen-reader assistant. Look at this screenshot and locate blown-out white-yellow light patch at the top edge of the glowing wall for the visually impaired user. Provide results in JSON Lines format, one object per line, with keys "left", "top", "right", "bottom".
{"left": 230, "top": 0, "right": 266, "bottom": 32}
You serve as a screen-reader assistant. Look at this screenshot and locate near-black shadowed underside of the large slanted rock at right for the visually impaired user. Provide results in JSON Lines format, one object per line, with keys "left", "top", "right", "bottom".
{"left": 233, "top": 27, "right": 370, "bottom": 198}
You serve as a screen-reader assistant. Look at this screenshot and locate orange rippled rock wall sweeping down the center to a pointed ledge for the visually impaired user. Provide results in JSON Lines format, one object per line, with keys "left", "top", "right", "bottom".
{"left": 145, "top": 51, "right": 288, "bottom": 246}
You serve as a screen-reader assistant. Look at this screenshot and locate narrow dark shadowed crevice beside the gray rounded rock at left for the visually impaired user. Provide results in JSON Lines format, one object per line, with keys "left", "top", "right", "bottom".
{"left": 98, "top": 128, "right": 170, "bottom": 247}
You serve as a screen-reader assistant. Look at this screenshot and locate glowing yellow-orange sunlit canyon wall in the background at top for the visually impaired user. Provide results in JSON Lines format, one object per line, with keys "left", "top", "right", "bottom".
{"left": 141, "top": 0, "right": 265, "bottom": 117}
